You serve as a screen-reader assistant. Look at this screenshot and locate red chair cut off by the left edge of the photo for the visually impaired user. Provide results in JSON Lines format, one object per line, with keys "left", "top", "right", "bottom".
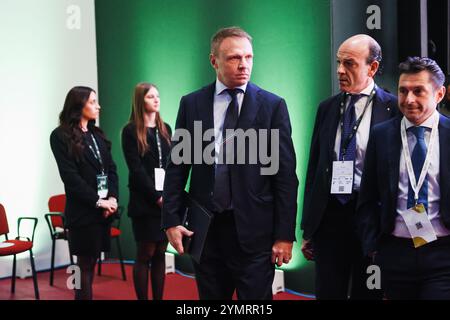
{"left": 0, "top": 204, "right": 39, "bottom": 300}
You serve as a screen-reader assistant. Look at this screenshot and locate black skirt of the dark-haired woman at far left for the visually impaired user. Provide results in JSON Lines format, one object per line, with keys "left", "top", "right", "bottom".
{"left": 68, "top": 224, "right": 111, "bottom": 257}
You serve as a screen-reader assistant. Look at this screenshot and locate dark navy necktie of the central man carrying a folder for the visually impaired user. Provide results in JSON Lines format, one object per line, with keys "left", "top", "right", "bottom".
{"left": 214, "top": 89, "right": 242, "bottom": 212}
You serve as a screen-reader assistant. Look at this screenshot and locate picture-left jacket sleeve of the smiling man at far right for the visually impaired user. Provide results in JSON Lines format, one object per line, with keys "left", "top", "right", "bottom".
{"left": 356, "top": 127, "right": 386, "bottom": 255}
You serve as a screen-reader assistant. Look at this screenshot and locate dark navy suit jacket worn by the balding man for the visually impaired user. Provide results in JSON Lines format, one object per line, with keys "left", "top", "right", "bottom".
{"left": 301, "top": 88, "right": 399, "bottom": 239}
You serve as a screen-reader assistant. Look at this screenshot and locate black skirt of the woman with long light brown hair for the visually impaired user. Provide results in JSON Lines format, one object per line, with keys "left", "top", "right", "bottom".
{"left": 131, "top": 215, "right": 167, "bottom": 242}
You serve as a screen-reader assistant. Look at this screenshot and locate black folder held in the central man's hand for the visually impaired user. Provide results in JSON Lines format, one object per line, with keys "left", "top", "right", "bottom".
{"left": 183, "top": 197, "right": 213, "bottom": 263}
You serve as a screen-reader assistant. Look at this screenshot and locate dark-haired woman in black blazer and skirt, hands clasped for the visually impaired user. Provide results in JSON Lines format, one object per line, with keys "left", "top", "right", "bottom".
{"left": 50, "top": 87, "right": 118, "bottom": 300}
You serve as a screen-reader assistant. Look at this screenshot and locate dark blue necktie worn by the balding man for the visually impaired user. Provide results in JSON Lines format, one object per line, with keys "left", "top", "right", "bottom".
{"left": 336, "top": 94, "right": 364, "bottom": 204}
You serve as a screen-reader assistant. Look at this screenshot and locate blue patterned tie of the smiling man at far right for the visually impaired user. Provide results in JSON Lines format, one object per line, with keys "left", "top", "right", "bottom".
{"left": 408, "top": 127, "right": 428, "bottom": 211}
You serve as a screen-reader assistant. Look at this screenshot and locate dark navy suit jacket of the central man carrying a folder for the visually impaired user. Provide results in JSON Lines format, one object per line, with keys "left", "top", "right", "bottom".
{"left": 162, "top": 83, "right": 298, "bottom": 251}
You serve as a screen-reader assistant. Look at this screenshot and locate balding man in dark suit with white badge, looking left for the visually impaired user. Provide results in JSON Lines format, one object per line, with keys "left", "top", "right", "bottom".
{"left": 301, "top": 35, "right": 397, "bottom": 299}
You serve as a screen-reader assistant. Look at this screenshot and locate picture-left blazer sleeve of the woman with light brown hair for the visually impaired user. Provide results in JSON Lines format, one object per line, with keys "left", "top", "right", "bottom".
{"left": 122, "top": 126, "right": 160, "bottom": 203}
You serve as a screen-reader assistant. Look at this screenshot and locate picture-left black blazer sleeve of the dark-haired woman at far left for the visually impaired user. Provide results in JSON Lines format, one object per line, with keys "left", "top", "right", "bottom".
{"left": 50, "top": 129, "right": 99, "bottom": 208}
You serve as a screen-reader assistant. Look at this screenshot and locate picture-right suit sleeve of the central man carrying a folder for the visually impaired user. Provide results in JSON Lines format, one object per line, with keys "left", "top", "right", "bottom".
{"left": 272, "top": 99, "right": 298, "bottom": 241}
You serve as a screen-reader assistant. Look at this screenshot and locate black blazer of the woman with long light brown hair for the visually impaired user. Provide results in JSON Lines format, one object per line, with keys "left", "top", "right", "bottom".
{"left": 122, "top": 123, "right": 171, "bottom": 217}
